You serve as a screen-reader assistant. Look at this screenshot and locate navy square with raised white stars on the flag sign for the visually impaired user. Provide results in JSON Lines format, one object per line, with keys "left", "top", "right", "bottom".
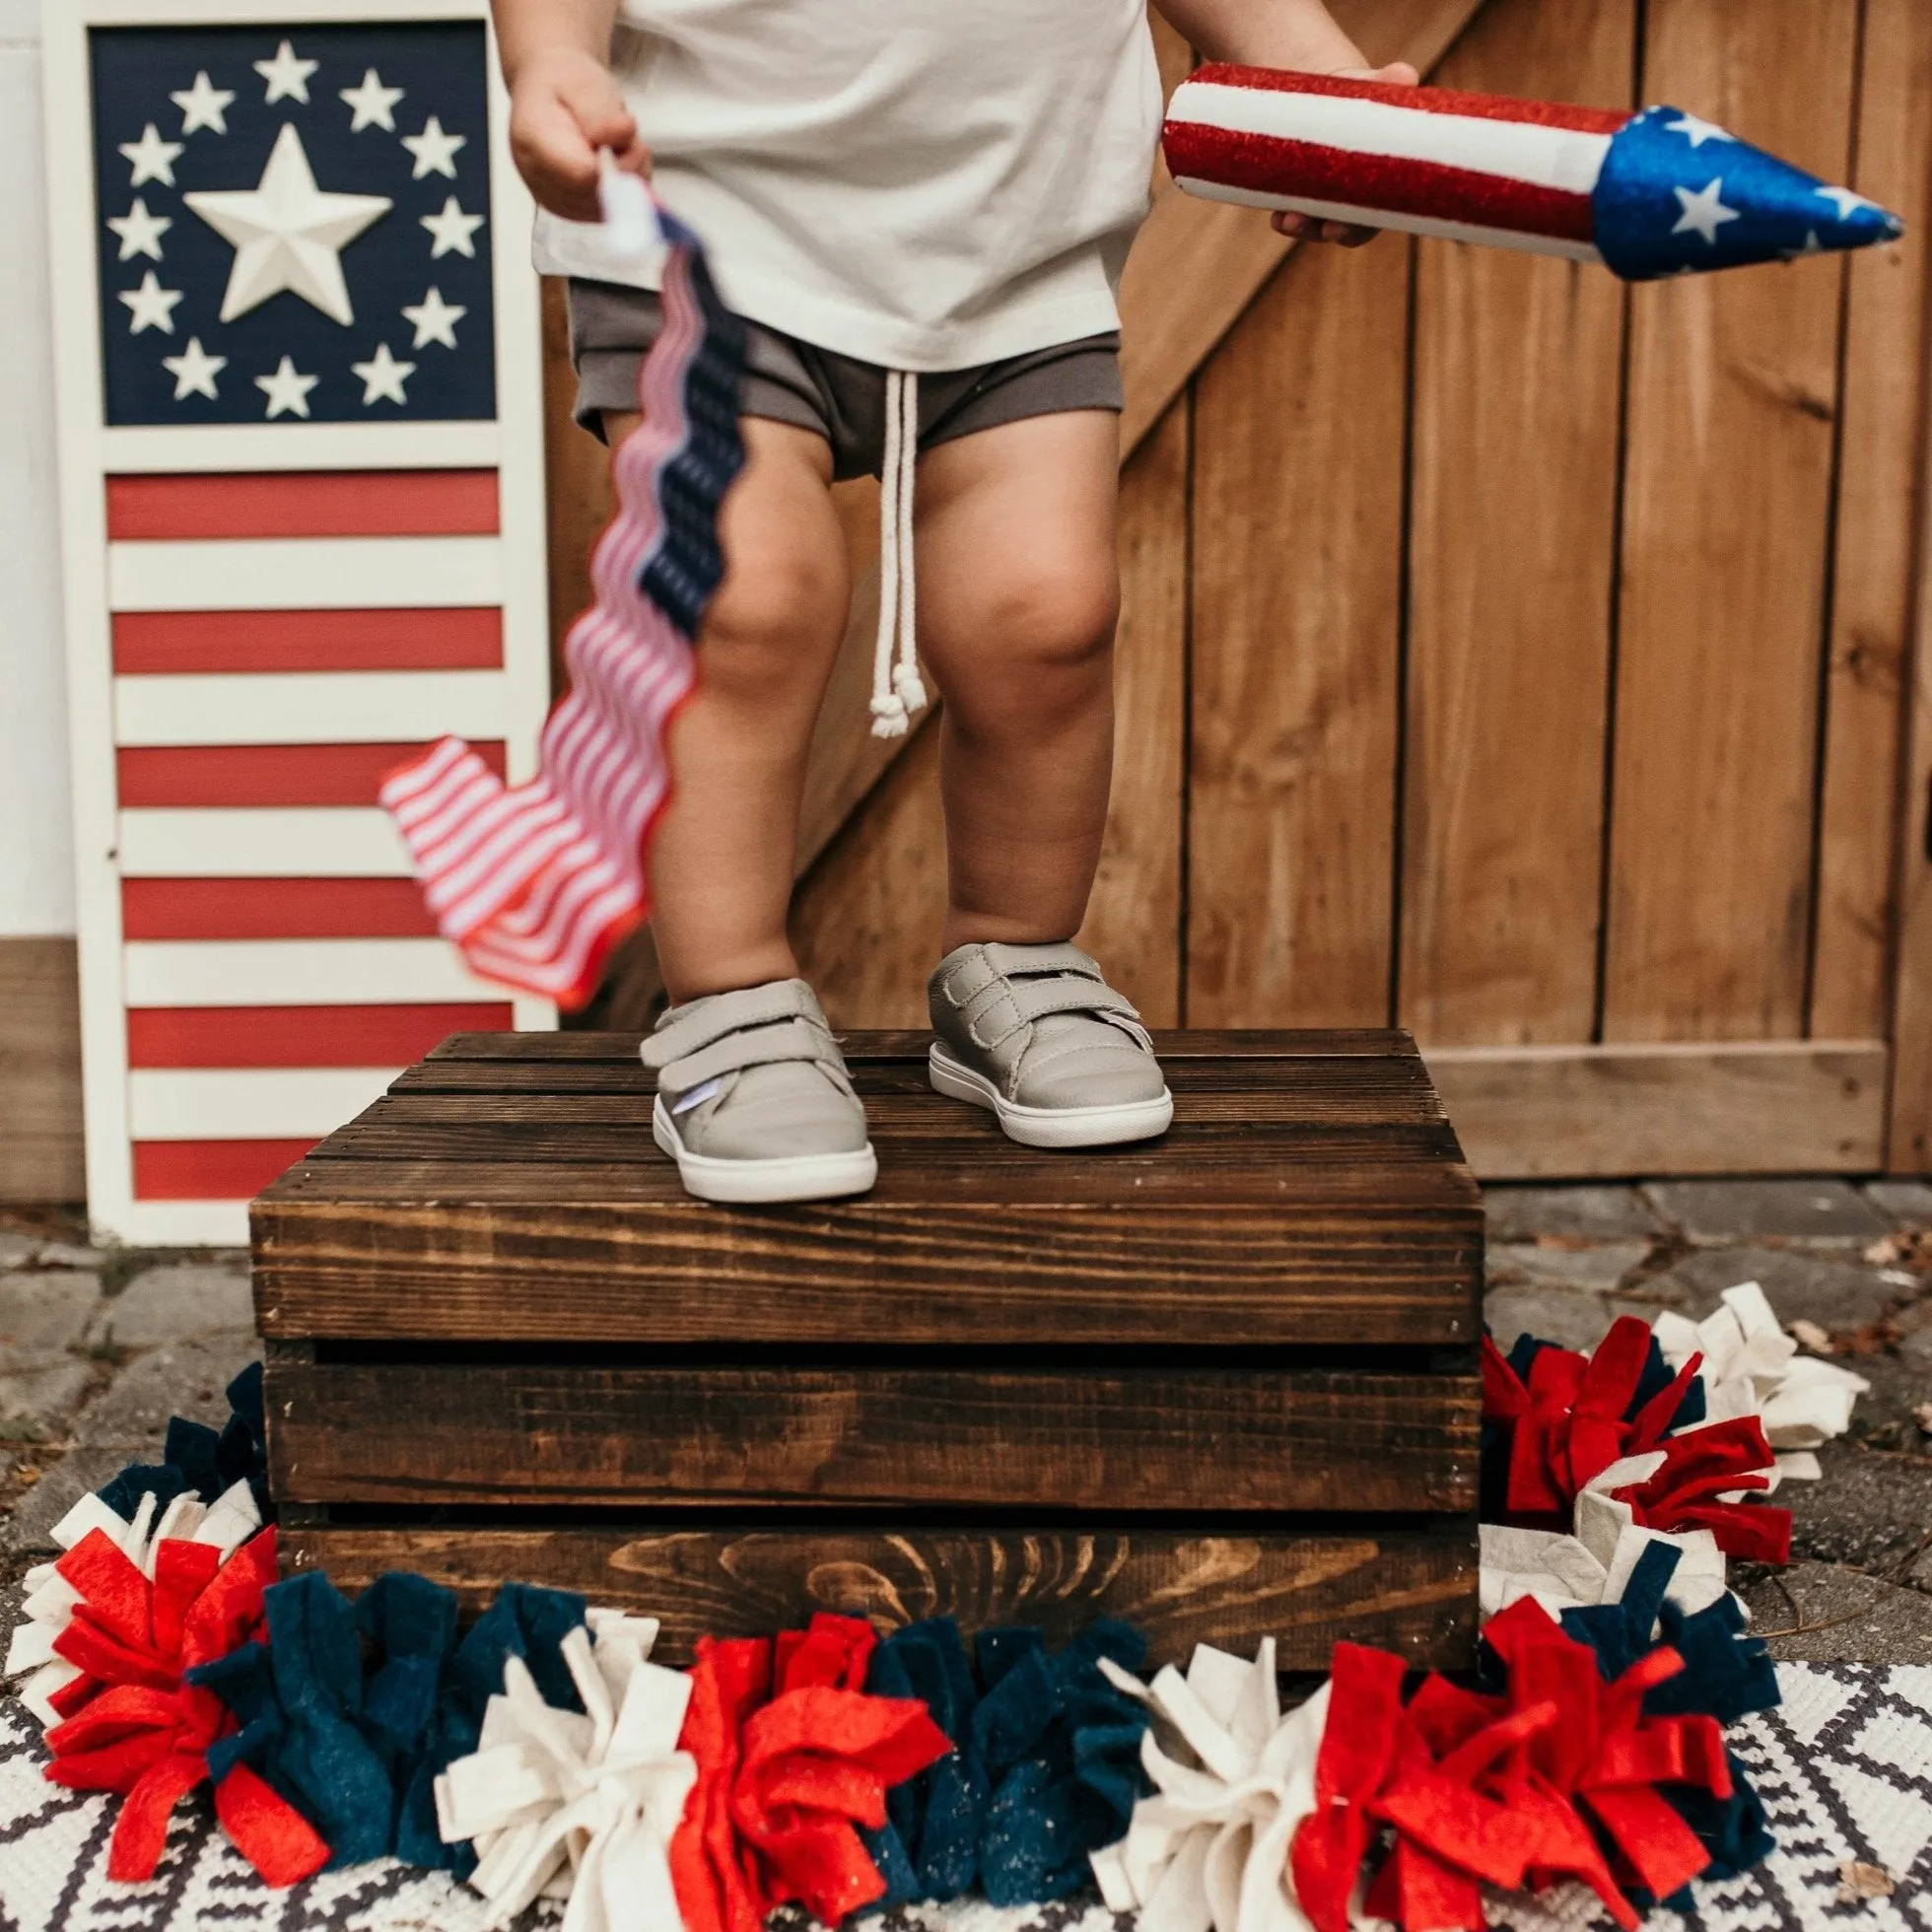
{"left": 89, "top": 22, "right": 497, "bottom": 425}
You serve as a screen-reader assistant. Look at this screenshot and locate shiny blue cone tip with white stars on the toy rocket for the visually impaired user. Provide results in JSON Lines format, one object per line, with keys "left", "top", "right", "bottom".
{"left": 1590, "top": 108, "right": 1905, "bottom": 282}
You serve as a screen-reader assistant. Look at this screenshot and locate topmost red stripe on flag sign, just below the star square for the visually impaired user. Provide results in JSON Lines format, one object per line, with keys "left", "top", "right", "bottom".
{"left": 108, "top": 469, "right": 501, "bottom": 541}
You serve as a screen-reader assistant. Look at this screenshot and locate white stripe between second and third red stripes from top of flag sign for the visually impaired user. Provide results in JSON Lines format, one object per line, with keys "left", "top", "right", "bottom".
{"left": 114, "top": 670, "right": 512, "bottom": 746}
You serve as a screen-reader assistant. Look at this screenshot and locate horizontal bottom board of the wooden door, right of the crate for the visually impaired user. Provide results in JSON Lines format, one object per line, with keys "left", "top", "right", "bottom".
{"left": 1422, "top": 1039, "right": 1888, "bottom": 1181}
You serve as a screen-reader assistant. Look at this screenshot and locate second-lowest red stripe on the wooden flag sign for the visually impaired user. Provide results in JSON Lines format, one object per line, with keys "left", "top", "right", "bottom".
{"left": 127, "top": 1000, "right": 516, "bottom": 1067}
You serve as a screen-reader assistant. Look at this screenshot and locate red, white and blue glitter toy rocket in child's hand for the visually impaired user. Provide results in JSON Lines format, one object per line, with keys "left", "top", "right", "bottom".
{"left": 1163, "top": 66, "right": 1903, "bottom": 282}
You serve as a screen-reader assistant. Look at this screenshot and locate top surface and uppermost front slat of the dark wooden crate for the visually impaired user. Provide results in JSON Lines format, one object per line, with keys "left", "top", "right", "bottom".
{"left": 253, "top": 1034, "right": 1482, "bottom": 1345}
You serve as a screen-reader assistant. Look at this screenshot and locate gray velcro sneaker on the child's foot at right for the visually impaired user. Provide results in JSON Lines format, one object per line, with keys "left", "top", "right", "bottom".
{"left": 926, "top": 944, "right": 1175, "bottom": 1147}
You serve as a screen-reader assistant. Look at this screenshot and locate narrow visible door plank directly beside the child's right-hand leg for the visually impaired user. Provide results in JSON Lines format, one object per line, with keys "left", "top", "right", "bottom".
{"left": 1080, "top": 396, "right": 1188, "bottom": 1026}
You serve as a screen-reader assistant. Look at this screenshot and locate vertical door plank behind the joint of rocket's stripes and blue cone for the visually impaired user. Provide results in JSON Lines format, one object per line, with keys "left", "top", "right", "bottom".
{"left": 1399, "top": 0, "right": 1636, "bottom": 1045}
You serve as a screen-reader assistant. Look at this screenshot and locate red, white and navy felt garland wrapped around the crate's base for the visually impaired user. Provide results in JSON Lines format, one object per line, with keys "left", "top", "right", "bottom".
{"left": 6, "top": 1282, "right": 1864, "bottom": 1932}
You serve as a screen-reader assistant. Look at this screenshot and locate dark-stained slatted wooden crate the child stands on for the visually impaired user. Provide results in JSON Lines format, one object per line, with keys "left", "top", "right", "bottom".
{"left": 253, "top": 1032, "right": 1482, "bottom": 1669}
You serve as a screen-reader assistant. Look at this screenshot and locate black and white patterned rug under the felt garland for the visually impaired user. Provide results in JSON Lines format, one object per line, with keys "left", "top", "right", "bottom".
{"left": 0, "top": 1664, "right": 1932, "bottom": 1932}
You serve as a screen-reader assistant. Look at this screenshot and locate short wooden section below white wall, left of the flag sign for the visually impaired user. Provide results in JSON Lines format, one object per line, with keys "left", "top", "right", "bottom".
{"left": 0, "top": 939, "right": 87, "bottom": 1202}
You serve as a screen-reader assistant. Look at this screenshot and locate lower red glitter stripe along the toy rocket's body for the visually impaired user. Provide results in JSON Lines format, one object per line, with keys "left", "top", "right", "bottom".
{"left": 1163, "top": 121, "right": 1592, "bottom": 242}
